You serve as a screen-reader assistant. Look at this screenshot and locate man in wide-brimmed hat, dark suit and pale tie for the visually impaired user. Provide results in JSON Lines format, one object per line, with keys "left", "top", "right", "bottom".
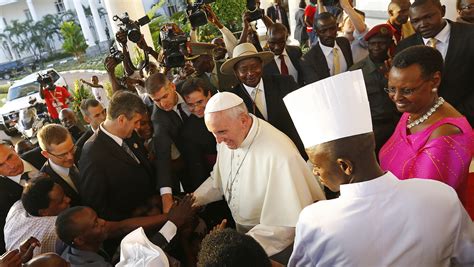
{"left": 221, "top": 43, "right": 307, "bottom": 159}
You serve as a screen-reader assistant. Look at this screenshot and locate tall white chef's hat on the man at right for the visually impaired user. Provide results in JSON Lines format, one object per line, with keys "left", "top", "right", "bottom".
{"left": 283, "top": 70, "right": 372, "bottom": 148}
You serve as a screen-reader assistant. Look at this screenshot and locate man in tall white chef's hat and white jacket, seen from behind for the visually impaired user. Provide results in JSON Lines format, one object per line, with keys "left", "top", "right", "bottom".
{"left": 285, "top": 70, "right": 474, "bottom": 266}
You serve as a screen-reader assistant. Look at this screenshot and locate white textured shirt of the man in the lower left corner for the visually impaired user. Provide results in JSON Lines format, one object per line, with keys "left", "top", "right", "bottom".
{"left": 4, "top": 200, "right": 59, "bottom": 256}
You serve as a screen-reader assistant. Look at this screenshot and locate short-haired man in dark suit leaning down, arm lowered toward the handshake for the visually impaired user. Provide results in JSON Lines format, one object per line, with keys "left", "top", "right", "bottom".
{"left": 145, "top": 73, "right": 190, "bottom": 212}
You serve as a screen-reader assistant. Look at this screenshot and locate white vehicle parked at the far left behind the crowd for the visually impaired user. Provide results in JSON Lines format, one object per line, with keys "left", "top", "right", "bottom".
{"left": 0, "top": 69, "right": 68, "bottom": 136}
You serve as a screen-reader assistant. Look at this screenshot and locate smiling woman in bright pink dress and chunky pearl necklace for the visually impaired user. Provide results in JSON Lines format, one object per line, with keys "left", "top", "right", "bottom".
{"left": 379, "top": 46, "right": 474, "bottom": 203}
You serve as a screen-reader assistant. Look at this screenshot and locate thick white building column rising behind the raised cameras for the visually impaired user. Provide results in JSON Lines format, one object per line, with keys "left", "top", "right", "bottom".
{"left": 104, "top": 0, "right": 155, "bottom": 61}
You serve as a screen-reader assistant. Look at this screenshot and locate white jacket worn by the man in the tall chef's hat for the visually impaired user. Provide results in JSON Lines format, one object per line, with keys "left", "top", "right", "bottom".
{"left": 288, "top": 172, "right": 474, "bottom": 266}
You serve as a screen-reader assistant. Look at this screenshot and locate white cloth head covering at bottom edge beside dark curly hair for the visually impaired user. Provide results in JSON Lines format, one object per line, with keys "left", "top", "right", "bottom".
{"left": 115, "top": 227, "right": 169, "bottom": 267}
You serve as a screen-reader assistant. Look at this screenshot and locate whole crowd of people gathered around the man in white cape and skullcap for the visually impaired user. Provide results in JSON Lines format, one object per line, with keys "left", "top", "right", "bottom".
{"left": 0, "top": 0, "right": 474, "bottom": 267}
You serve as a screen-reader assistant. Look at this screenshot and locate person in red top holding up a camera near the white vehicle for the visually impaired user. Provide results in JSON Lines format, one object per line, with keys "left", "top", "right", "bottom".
{"left": 37, "top": 73, "right": 72, "bottom": 123}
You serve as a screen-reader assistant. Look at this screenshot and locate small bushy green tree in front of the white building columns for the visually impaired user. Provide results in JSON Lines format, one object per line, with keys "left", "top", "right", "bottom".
{"left": 61, "top": 21, "right": 87, "bottom": 61}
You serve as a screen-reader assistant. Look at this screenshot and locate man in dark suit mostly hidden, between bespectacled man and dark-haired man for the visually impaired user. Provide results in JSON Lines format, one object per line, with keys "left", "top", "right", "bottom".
{"left": 75, "top": 98, "right": 106, "bottom": 163}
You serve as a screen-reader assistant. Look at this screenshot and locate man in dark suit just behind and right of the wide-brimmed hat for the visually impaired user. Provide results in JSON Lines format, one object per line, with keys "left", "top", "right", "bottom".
{"left": 263, "top": 23, "right": 303, "bottom": 86}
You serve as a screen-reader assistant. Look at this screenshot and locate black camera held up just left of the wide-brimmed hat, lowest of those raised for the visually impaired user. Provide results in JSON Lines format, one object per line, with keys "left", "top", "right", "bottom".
{"left": 160, "top": 23, "right": 188, "bottom": 68}
